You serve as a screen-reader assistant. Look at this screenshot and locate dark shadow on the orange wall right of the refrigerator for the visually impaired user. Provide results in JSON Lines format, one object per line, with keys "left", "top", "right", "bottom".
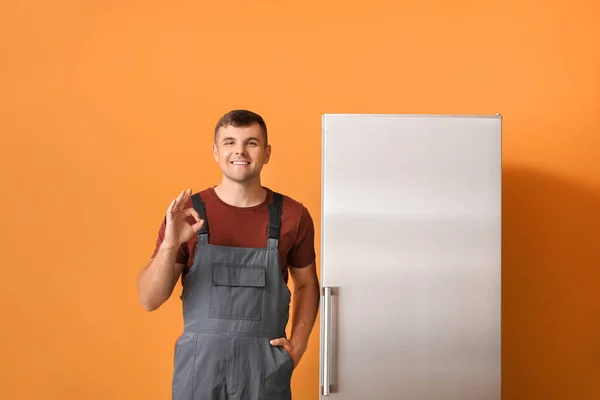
{"left": 502, "top": 166, "right": 600, "bottom": 400}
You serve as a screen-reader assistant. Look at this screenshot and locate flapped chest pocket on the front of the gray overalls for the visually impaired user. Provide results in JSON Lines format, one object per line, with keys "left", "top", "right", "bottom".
{"left": 209, "top": 263, "right": 266, "bottom": 321}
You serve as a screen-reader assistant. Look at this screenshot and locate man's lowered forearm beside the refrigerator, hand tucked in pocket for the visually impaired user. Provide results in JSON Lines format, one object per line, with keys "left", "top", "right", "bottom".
{"left": 290, "top": 281, "right": 320, "bottom": 352}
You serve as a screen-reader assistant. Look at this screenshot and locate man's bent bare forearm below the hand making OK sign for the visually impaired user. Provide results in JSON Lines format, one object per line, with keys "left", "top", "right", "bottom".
{"left": 138, "top": 247, "right": 181, "bottom": 311}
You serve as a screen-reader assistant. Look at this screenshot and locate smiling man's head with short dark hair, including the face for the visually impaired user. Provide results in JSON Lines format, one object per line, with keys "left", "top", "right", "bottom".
{"left": 213, "top": 110, "right": 271, "bottom": 182}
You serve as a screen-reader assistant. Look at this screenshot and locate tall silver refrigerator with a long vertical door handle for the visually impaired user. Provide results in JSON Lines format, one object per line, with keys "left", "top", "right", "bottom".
{"left": 320, "top": 114, "right": 502, "bottom": 400}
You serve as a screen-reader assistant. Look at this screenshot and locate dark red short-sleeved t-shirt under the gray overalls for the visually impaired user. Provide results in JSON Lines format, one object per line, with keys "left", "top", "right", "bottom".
{"left": 152, "top": 187, "right": 315, "bottom": 283}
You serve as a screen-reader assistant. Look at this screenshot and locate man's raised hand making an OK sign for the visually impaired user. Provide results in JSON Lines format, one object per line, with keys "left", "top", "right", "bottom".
{"left": 161, "top": 189, "right": 204, "bottom": 248}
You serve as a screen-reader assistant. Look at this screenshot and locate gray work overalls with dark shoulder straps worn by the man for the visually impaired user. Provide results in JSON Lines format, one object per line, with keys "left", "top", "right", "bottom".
{"left": 172, "top": 193, "right": 294, "bottom": 400}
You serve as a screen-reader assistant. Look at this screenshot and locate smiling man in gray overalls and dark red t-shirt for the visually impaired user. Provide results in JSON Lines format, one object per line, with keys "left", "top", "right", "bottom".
{"left": 138, "top": 110, "right": 319, "bottom": 400}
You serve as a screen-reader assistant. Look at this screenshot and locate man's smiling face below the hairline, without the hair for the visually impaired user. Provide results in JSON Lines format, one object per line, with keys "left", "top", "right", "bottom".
{"left": 213, "top": 124, "right": 271, "bottom": 182}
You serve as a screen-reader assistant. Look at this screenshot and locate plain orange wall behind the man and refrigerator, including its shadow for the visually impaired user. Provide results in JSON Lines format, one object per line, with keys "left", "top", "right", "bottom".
{"left": 0, "top": 0, "right": 600, "bottom": 400}
